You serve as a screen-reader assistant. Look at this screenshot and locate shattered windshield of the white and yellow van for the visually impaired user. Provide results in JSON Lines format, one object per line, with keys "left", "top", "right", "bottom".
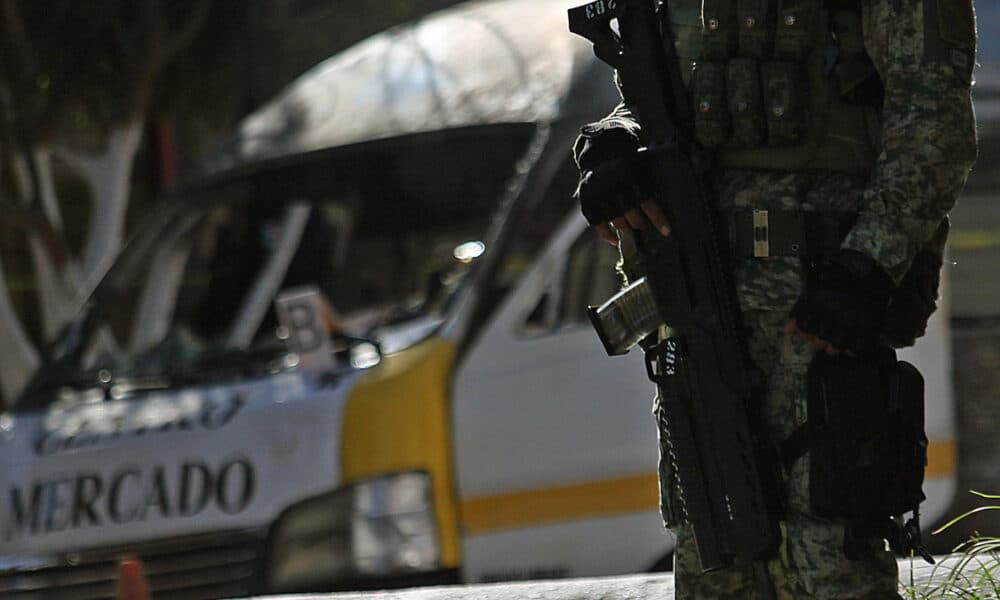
{"left": 22, "top": 126, "right": 548, "bottom": 408}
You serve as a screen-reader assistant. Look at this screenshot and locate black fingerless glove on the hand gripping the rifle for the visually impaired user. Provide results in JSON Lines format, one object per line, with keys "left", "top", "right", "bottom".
{"left": 574, "top": 150, "right": 670, "bottom": 241}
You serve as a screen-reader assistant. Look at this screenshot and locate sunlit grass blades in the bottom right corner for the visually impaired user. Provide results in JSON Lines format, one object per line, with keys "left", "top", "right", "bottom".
{"left": 904, "top": 491, "right": 1000, "bottom": 600}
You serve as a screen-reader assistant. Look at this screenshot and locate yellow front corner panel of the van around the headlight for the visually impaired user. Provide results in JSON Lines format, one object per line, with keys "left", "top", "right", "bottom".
{"left": 340, "top": 339, "right": 461, "bottom": 568}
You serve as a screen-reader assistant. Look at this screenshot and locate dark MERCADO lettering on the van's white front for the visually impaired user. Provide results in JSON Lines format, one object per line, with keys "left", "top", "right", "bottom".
{"left": 0, "top": 458, "right": 257, "bottom": 542}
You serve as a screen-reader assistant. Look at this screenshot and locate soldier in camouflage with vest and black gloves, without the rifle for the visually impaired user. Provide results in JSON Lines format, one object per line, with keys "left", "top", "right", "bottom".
{"left": 574, "top": 0, "right": 976, "bottom": 600}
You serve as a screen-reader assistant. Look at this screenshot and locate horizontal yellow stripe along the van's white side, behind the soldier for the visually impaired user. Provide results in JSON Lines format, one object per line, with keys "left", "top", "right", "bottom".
{"left": 462, "top": 440, "right": 957, "bottom": 535}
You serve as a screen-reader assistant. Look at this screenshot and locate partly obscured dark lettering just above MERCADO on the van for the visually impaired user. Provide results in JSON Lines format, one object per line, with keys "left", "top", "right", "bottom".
{"left": 35, "top": 394, "right": 247, "bottom": 456}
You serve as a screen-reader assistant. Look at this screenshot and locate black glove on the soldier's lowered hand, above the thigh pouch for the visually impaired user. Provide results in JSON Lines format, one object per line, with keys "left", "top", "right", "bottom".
{"left": 792, "top": 250, "right": 893, "bottom": 353}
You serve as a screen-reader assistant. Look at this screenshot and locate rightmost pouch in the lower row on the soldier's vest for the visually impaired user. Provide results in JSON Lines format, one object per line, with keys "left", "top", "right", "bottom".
{"left": 761, "top": 61, "right": 809, "bottom": 146}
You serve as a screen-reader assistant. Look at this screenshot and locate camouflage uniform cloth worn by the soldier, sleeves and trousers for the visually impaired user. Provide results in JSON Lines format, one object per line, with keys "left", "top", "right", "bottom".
{"left": 576, "top": 0, "right": 976, "bottom": 600}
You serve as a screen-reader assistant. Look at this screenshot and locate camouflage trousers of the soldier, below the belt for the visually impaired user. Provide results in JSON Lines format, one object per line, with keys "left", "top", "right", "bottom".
{"left": 658, "top": 311, "right": 898, "bottom": 600}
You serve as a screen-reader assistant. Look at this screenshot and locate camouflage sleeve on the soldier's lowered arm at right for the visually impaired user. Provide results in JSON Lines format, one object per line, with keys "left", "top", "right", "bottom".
{"left": 844, "top": 0, "right": 976, "bottom": 283}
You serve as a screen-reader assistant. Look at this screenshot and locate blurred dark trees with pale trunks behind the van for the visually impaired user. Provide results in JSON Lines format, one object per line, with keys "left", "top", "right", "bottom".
{"left": 0, "top": 0, "right": 468, "bottom": 406}
